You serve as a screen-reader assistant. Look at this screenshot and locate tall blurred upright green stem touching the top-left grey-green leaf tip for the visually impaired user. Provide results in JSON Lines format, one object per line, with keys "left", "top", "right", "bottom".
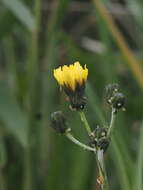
{"left": 23, "top": 0, "right": 41, "bottom": 190}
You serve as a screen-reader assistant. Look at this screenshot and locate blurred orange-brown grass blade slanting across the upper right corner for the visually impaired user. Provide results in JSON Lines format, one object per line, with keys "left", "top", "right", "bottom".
{"left": 93, "top": 0, "right": 143, "bottom": 88}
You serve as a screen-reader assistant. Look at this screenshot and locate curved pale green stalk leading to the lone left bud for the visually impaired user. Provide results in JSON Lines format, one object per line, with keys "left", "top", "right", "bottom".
{"left": 65, "top": 133, "right": 96, "bottom": 152}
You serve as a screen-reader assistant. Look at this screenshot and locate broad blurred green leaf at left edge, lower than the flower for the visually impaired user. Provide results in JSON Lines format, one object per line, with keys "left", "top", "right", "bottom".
{"left": 0, "top": 81, "right": 28, "bottom": 147}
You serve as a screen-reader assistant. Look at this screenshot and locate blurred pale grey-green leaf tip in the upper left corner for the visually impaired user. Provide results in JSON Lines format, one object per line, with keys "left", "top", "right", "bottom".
{"left": 2, "top": 0, "right": 35, "bottom": 31}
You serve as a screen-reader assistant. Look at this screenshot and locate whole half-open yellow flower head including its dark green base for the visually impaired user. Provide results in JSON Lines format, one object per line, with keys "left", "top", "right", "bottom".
{"left": 54, "top": 62, "right": 88, "bottom": 110}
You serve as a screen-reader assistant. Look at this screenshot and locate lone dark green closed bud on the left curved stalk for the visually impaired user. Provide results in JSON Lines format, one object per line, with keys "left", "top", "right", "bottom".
{"left": 51, "top": 111, "right": 68, "bottom": 134}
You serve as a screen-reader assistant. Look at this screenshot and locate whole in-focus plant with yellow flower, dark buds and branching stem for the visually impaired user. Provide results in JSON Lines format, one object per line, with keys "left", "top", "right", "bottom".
{"left": 51, "top": 62, "right": 125, "bottom": 190}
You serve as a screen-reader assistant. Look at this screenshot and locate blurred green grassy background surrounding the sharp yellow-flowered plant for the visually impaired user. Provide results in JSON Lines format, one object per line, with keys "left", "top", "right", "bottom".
{"left": 0, "top": 0, "right": 143, "bottom": 190}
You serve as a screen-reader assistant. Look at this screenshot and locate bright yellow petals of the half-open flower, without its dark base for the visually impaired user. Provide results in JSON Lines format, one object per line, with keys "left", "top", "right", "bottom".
{"left": 54, "top": 62, "right": 88, "bottom": 91}
